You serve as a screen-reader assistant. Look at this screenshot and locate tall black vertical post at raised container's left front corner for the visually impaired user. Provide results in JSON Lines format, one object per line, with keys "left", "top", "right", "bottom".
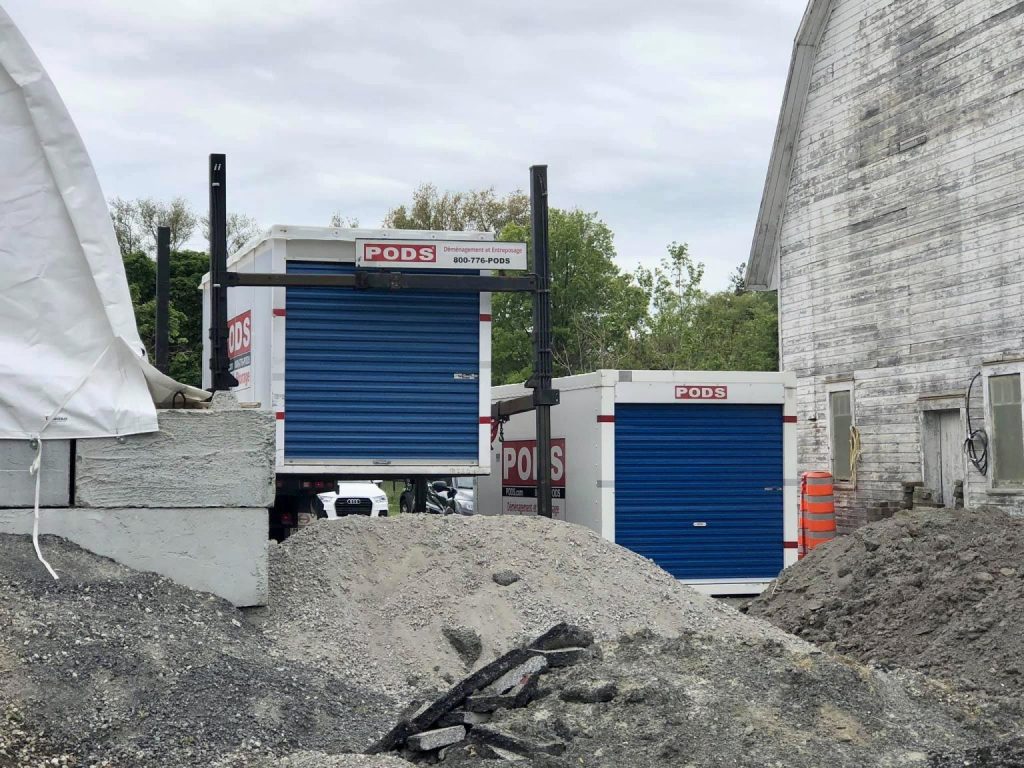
{"left": 210, "top": 155, "right": 239, "bottom": 392}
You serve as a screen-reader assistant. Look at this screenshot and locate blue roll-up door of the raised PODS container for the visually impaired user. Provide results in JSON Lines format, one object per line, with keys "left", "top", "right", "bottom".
{"left": 285, "top": 261, "right": 480, "bottom": 463}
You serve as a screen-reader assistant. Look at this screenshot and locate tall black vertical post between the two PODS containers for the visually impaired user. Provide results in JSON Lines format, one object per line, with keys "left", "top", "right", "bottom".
{"left": 529, "top": 165, "right": 552, "bottom": 517}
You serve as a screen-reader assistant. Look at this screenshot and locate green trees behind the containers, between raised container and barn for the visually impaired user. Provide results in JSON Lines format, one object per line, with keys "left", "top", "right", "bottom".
{"left": 384, "top": 184, "right": 778, "bottom": 384}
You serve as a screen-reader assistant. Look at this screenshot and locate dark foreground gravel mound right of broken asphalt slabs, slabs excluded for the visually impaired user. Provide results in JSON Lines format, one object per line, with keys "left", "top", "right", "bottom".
{"left": 443, "top": 632, "right": 1007, "bottom": 768}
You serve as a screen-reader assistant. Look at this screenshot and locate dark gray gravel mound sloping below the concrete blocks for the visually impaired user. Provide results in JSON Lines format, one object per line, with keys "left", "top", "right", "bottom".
{"left": 0, "top": 536, "right": 394, "bottom": 768}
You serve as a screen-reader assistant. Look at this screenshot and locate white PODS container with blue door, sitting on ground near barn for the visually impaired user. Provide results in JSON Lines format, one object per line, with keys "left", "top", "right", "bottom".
{"left": 477, "top": 371, "right": 799, "bottom": 594}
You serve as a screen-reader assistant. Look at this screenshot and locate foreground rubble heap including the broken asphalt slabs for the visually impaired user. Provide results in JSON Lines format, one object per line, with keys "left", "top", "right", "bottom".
{"left": 372, "top": 625, "right": 1005, "bottom": 768}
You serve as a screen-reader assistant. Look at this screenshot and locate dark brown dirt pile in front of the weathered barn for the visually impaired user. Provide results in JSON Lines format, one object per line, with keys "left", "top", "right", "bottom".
{"left": 748, "top": 510, "right": 1024, "bottom": 697}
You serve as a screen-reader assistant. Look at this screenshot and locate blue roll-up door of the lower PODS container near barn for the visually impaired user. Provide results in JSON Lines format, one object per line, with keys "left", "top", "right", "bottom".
{"left": 615, "top": 403, "right": 782, "bottom": 580}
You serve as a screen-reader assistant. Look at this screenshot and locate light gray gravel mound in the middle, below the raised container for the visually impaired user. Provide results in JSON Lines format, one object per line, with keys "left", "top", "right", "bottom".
{"left": 253, "top": 515, "right": 797, "bottom": 698}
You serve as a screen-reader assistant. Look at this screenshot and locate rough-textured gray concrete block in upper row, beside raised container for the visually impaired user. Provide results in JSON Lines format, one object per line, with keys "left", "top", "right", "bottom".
{"left": 75, "top": 409, "right": 274, "bottom": 508}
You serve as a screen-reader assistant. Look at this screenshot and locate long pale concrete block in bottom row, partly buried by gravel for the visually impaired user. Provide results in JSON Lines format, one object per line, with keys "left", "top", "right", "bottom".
{"left": 0, "top": 507, "right": 267, "bottom": 606}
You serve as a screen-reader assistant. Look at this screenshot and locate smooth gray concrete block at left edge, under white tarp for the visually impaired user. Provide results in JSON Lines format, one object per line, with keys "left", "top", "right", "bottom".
{"left": 0, "top": 440, "right": 71, "bottom": 507}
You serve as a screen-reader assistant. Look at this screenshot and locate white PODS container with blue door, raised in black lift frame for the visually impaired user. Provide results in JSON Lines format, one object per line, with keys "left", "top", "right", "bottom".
{"left": 202, "top": 226, "right": 494, "bottom": 477}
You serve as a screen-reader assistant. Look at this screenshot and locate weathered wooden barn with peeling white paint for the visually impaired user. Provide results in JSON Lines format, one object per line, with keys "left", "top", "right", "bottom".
{"left": 746, "top": 0, "right": 1024, "bottom": 529}
